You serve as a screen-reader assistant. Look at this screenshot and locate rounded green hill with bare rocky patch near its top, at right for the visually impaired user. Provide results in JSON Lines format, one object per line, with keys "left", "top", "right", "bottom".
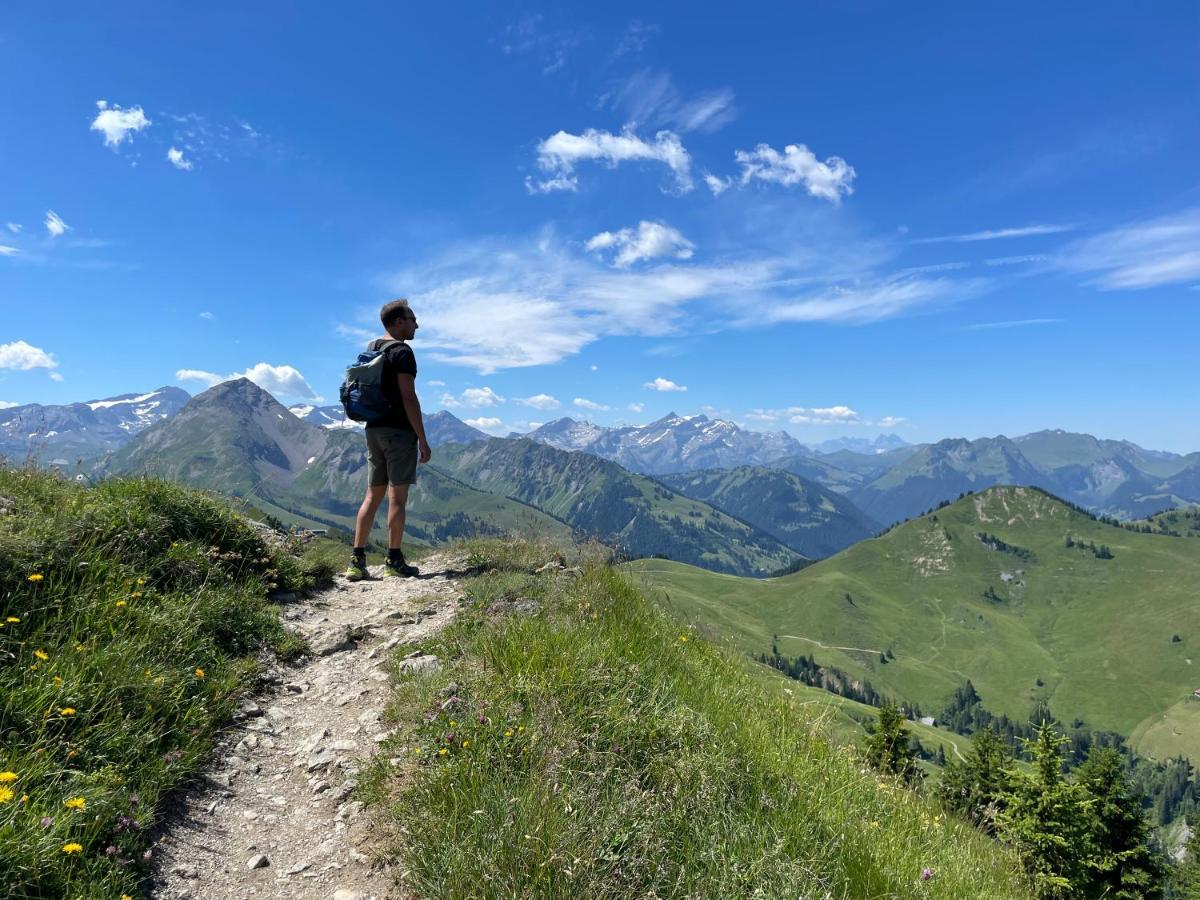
{"left": 630, "top": 488, "right": 1200, "bottom": 758}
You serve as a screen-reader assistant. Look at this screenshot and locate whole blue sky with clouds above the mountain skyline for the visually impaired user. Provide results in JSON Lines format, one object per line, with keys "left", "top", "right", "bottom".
{"left": 7, "top": 2, "right": 1200, "bottom": 451}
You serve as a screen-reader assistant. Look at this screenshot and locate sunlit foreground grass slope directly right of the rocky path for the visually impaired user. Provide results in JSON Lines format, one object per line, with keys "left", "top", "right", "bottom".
{"left": 365, "top": 540, "right": 1028, "bottom": 898}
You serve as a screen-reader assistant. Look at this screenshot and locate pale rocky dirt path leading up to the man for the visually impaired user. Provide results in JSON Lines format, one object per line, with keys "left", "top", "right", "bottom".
{"left": 151, "top": 554, "right": 461, "bottom": 900}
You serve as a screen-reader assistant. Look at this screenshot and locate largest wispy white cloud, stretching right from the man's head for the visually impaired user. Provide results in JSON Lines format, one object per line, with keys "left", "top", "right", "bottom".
{"left": 384, "top": 230, "right": 985, "bottom": 374}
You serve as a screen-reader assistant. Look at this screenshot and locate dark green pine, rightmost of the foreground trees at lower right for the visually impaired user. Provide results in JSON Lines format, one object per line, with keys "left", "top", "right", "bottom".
{"left": 1075, "top": 746, "right": 1164, "bottom": 899}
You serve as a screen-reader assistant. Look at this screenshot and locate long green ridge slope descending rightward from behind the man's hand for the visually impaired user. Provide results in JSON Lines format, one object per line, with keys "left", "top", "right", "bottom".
{"left": 432, "top": 438, "right": 798, "bottom": 575}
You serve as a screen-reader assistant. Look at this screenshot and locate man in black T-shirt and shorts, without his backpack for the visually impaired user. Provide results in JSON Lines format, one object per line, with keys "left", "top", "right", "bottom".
{"left": 346, "top": 300, "right": 432, "bottom": 581}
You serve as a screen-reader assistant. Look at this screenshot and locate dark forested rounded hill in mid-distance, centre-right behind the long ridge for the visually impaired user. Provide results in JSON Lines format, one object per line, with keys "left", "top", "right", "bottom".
{"left": 659, "top": 466, "right": 878, "bottom": 559}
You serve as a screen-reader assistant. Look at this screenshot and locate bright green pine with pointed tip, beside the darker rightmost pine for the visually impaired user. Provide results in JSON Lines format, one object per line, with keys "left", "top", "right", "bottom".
{"left": 996, "top": 721, "right": 1096, "bottom": 898}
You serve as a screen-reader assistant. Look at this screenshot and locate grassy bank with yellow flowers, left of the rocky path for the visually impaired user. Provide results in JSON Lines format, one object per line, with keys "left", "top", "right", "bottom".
{"left": 0, "top": 469, "right": 331, "bottom": 898}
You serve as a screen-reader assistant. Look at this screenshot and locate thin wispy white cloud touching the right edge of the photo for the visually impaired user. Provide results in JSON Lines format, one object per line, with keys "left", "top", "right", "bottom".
{"left": 1054, "top": 209, "right": 1200, "bottom": 290}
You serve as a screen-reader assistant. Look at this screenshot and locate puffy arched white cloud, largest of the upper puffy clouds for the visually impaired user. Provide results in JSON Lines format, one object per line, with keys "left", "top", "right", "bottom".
{"left": 526, "top": 128, "right": 692, "bottom": 193}
